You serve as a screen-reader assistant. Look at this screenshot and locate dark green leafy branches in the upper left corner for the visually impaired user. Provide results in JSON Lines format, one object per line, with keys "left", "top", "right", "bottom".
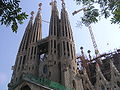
{"left": 0, "top": 0, "right": 28, "bottom": 32}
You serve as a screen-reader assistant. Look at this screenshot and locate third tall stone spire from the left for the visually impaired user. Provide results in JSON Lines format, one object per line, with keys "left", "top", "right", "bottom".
{"left": 42, "top": 0, "right": 60, "bottom": 82}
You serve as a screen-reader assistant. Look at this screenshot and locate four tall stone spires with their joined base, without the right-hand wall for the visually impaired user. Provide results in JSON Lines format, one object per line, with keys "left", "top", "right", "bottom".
{"left": 8, "top": 0, "right": 81, "bottom": 90}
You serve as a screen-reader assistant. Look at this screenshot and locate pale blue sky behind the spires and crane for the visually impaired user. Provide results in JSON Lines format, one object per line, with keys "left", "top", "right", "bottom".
{"left": 0, "top": 0, "right": 120, "bottom": 90}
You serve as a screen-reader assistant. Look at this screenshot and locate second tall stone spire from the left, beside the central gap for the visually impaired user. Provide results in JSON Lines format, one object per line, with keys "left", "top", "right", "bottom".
{"left": 25, "top": 3, "right": 42, "bottom": 76}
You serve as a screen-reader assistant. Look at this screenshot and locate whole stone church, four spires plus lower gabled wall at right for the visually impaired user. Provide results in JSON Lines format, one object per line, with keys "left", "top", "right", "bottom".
{"left": 8, "top": 0, "right": 120, "bottom": 90}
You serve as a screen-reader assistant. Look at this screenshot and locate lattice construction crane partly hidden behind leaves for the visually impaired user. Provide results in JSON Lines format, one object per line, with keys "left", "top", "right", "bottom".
{"left": 72, "top": 7, "right": 100, "bottom": 57}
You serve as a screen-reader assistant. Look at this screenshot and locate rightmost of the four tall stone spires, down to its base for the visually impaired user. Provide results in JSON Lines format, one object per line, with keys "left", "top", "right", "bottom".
{"left": 59, "top": 0, "right": 77, "bottom": 90}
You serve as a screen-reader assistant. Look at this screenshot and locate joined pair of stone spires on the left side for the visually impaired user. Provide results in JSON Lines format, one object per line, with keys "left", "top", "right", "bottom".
{"left": 8, "top": 3, "right": 42, "bottom": 83}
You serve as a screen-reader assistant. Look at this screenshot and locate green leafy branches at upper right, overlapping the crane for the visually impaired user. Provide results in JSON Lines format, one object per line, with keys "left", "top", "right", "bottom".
{"left": 75, "top": 0, "right": 120, "bottom": 25}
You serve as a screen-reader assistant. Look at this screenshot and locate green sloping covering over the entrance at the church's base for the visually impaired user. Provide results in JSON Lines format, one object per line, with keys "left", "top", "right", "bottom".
{"left": 8, "top": 74, "right": 74, "bottom": 90}
